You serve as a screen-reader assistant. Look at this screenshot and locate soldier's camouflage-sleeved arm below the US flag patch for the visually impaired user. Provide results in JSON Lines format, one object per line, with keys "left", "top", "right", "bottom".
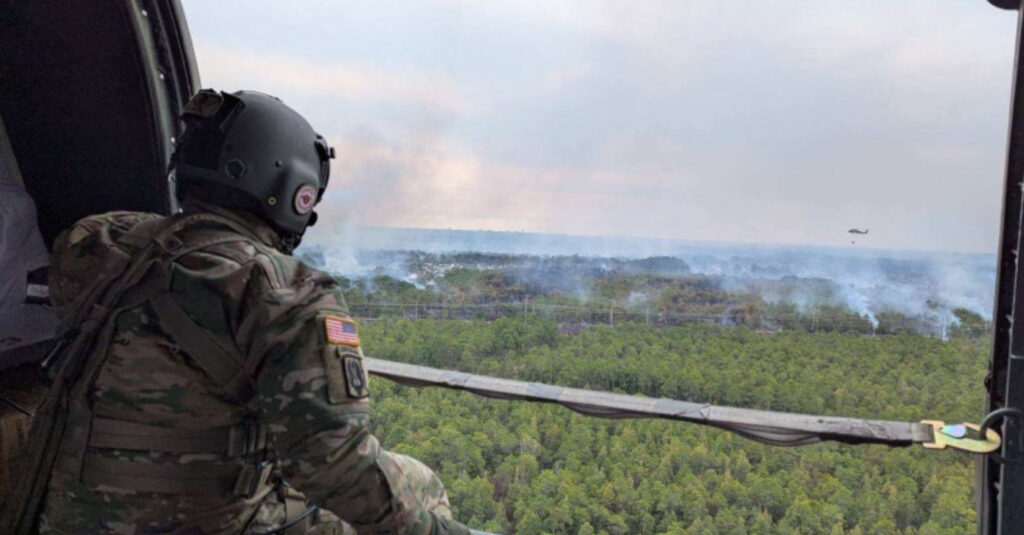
{"left": 247, "top": 296, "right": 469, "bottom": 535}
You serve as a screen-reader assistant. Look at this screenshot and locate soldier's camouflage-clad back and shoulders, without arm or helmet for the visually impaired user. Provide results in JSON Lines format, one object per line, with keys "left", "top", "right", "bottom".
{"left": 39, "top": 212, "right": 325, "bottom": 534}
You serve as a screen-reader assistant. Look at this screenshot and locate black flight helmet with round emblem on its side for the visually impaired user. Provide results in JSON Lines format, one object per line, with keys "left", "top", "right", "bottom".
{"left": 171, "top": 89, "right": 334, "bottom": 251}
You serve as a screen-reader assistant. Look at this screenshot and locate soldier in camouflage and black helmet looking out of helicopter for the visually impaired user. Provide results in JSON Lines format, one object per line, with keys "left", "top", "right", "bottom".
{"left": 7, "top": 90, "right": 470, "bottom": 535}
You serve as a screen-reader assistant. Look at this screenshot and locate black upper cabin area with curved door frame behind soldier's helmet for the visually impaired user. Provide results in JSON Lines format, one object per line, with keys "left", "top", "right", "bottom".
{"left": 0, "top": 2, "right": 195, "bottom": 244}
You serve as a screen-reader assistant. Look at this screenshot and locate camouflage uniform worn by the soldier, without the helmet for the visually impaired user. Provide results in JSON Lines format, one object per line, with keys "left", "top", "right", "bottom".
{"left": 38, "top": 201, "right": 468, "bottom": 535}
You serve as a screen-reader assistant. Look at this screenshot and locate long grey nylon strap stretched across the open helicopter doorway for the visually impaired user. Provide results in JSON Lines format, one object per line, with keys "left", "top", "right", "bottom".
{"left": 362, "top": 358, "right": 933, "bottom": 446}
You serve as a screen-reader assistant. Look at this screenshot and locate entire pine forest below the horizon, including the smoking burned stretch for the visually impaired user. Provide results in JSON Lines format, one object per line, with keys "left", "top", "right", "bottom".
{"left": 304, "top": 250, "right": 990, "bottom": 535}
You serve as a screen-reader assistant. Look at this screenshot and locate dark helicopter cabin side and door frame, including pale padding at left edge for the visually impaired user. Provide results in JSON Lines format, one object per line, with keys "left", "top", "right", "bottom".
{"left": 0, "top": 0, "right": 198, "bottom": 369}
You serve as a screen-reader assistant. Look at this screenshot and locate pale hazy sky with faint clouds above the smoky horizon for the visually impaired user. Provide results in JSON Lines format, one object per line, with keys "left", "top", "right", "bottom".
{"left": 183, "top": 0, "right": 1016, "bottom": 252}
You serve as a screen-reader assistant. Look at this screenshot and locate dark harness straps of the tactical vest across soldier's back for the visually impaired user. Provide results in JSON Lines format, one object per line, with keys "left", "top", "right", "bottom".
{"left": 0, "top": 213, "right": 308, "bottom": 535}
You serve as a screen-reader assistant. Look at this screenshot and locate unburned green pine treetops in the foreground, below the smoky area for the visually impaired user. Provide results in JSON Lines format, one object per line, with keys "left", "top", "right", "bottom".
{"left": 362, "top": 315, "right": 989, "bottom": 535}
